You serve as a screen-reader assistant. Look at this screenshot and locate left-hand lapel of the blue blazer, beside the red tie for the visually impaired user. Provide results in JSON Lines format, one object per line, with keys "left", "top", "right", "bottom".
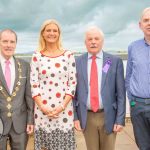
{"left": 81, "top": 53, "right": 88, "bottom": 91}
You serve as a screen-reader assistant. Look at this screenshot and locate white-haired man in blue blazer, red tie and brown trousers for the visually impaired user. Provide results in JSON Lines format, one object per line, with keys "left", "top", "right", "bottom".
{"left": 73, "top": 27, "right": 125, "bottom": 150}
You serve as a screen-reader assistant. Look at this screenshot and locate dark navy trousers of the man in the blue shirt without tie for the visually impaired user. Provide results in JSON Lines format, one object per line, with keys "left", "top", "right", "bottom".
{"left": 131, "top": 101, "right": 150, "bottom": 150}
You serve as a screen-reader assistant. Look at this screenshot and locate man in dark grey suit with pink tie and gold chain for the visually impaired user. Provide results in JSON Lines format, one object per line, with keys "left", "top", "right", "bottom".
{"left": 0, "top": 29, "right": 34, "bottom": 150}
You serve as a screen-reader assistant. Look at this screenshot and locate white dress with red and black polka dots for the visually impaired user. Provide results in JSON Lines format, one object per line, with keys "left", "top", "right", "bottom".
{"left": 30, "top": 51, "right": 76, "bottom": 150}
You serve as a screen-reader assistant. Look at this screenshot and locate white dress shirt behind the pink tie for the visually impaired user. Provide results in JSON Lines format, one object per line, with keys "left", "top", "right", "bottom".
{"left": 0, "top": 54, "right": 16, "bottom": 94}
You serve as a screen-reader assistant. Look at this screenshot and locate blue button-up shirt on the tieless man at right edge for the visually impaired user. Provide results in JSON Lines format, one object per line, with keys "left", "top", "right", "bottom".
{"left": 126, "top": 39, "right": 150, "bottom": 100}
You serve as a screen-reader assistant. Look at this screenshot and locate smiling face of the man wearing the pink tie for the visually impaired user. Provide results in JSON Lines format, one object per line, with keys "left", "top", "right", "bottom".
{"left": 0, "top": 30, "right": 16, "bottom": 59}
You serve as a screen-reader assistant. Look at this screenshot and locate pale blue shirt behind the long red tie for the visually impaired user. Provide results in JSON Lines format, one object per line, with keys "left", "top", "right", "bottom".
{"left": 87, "top": 51, "right": 103, "bottom": 110}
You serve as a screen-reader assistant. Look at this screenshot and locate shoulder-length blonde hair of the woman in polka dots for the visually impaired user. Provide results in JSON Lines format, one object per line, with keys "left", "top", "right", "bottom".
{"left": 38, "top": 19, "right": 62, "bottom": 51}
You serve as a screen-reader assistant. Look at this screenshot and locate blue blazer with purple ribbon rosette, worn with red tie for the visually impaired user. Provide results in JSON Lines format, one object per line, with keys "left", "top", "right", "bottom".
{"left": 73, "top": 52, "right": 125, "bottom": 133}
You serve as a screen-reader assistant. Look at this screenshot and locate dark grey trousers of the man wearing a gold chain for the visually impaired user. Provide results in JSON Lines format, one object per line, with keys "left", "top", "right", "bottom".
{"left": 0, "top": 125, "right": 28, "bottom": 150}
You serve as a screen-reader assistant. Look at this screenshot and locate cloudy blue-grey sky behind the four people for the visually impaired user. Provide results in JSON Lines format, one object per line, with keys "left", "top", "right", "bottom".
{"left": 0, "top": 0, "right": 150, "bottom": 53}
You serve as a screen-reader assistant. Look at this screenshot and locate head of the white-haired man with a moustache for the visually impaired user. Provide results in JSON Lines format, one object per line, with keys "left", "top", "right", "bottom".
{"left": 85, "top": 28, "right": 104, "bottom": 55}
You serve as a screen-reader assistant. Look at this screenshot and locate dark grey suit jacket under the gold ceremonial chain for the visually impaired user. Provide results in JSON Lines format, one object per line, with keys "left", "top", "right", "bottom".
{"left": 0, "top": 57, "right": 34, "bottom": 135}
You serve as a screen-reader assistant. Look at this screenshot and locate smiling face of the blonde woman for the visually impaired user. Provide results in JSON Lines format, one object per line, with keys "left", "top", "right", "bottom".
{"left": 43, "top": 23, "right": 60, "bottom": 44}
